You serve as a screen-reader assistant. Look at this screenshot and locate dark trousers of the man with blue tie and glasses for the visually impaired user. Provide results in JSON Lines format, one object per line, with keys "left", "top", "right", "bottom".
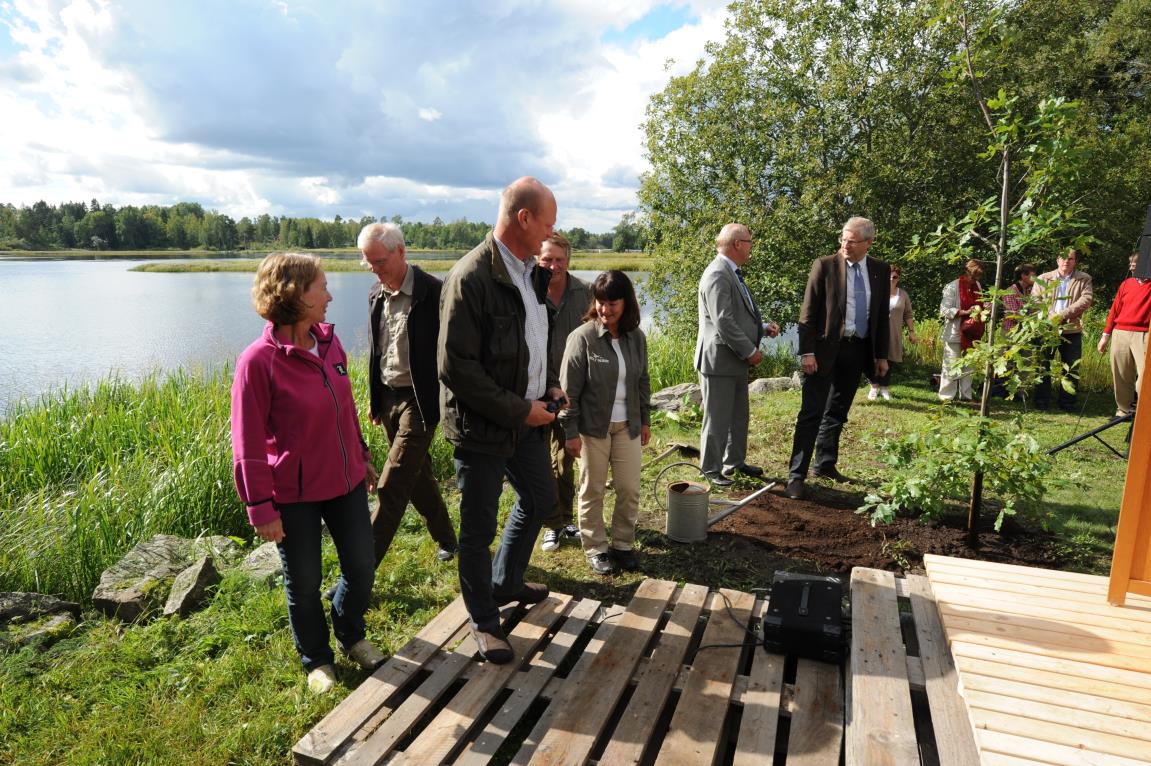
{"left": 787, "top": 339, "right": 871, "bottom": 478}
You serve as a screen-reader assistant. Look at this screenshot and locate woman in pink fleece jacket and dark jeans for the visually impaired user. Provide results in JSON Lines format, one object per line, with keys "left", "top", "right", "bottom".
{"left": 231, "top": 253, "right": 384, "bottom": 694}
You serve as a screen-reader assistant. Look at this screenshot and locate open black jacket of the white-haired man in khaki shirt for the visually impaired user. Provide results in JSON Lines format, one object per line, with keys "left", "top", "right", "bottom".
{"left": 367, "top": 263, "right": 441, "bottom": 430}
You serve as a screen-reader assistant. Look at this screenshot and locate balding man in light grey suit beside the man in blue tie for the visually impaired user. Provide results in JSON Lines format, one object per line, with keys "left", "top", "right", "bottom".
{"left": 695, "top": 223, "right": 779, "bottom": 487}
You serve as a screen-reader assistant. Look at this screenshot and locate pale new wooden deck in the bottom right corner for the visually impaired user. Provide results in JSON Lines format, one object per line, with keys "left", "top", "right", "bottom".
{"left": 925, "top": 556, "right": 1151, "bottom": 766}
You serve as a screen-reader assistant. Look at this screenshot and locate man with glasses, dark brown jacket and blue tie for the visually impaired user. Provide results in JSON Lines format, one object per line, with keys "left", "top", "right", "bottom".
{"left": 786, "top": 217, "right": 891, "bottom": 499}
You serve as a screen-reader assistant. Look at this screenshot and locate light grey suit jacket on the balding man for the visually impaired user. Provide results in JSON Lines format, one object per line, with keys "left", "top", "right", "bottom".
{"left": 695, "top": 254, "right": 763, "bottom": 375}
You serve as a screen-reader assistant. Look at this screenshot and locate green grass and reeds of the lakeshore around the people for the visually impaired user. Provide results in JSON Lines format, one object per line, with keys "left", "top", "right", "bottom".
{"left": 0, "top": 328, "right": 1125, "bottom": 766}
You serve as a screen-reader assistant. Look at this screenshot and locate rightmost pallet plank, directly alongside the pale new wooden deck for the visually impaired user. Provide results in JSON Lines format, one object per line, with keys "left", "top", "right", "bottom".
{"left": 905, "top": 575, "right": 980, "bottom": 766}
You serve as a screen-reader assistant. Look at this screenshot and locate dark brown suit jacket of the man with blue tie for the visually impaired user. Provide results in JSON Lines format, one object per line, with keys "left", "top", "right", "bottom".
{"left": 799, "top": 252, "right": 891, "bottom": 375}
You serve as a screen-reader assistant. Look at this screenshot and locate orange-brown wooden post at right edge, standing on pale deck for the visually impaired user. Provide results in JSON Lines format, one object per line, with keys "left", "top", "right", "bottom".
{"left": 1107, "top": 333, "right": 1151, "bottom": 605}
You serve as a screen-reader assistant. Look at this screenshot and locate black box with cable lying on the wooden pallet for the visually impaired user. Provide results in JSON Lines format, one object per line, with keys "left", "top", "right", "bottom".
{"left": 763, "top": 572, "right": 846, "bottom": 662}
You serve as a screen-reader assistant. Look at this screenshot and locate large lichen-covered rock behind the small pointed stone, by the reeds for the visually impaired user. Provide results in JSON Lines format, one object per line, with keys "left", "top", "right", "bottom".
{"left": 92, "top": 535, "right": 242, "bottom": 621}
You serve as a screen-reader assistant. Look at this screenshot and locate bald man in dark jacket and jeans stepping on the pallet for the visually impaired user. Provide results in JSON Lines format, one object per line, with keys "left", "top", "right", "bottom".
{"left": 437, "top": 177, "right": 564, "bottom": 665}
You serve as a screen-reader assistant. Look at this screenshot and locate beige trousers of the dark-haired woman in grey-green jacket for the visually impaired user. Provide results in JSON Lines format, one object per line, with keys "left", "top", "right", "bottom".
{"left": 579, "top": 421, "right": 642, "bottom": 558}
